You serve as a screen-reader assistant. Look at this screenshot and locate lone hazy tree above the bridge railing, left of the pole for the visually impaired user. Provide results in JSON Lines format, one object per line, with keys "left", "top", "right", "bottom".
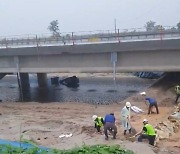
{"left": 48, "top": 20, "right": 60, "bottom": 37}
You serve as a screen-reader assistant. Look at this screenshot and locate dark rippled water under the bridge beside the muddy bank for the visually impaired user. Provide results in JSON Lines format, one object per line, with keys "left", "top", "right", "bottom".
{"left": 0, "top": 75, "right": 155, "bottom": 104}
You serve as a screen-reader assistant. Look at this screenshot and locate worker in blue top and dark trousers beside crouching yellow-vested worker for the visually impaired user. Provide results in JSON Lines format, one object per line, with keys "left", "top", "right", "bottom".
{"left": 104, "top": 113, "right": 117, "bottom": 140}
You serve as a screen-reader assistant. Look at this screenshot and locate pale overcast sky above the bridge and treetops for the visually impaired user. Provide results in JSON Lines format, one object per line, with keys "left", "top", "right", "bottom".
{"left": 0, "top": 0, "right": 180, "bottom": 36}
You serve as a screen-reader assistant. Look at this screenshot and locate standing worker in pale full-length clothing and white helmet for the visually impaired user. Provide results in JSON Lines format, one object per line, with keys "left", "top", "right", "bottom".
{"left": 121, "top": 102, "right": 131, "bottom": 135}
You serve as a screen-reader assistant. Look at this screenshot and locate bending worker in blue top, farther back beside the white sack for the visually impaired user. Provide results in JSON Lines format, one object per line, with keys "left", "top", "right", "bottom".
{"left": 140, "top": 92, "right": 159, "bottom": 114}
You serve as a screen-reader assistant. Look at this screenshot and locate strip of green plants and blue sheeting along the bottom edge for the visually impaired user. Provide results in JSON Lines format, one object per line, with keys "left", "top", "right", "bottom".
{"left": 0, "top": 145, "right": 134, "bottom": 154}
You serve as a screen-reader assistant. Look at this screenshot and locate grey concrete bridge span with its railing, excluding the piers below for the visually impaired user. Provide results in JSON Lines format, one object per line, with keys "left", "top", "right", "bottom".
{"left": 0, "top": 30, "right": 180, "bottom": 88}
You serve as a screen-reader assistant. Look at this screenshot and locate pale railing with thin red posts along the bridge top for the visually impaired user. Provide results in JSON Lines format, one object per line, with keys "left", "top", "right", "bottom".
{"left": 0, "top": 26, "right": 180, "bottom": 48}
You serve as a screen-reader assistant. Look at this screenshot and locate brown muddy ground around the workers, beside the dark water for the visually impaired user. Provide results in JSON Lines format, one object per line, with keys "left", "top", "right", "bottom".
{"left": 0, "top": 74, "right": 180, "bottom": 154}
